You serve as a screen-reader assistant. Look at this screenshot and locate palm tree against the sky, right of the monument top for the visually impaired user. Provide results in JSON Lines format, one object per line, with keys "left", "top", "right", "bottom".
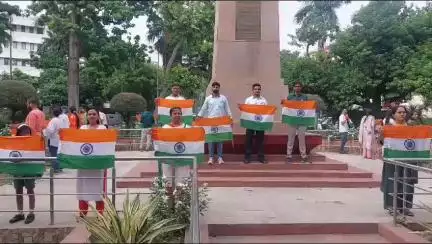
{"left": 295, "top": 1, "right": 351, "bottom": 51}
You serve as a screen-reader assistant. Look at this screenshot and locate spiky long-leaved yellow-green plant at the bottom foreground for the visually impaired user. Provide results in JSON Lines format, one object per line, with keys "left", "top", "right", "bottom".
{"left": 83, "top": 192, "right": 185, "bottom": 243}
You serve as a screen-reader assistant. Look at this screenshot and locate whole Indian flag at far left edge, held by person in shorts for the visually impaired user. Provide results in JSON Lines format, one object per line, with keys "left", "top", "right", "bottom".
{"left": 0, "top": 136, "right": 45, "bottom": 176}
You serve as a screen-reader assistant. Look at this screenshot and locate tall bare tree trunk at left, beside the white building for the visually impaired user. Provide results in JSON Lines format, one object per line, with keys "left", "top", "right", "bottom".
{"left": 68, "top": 7, "right": 80, "bottom": 108}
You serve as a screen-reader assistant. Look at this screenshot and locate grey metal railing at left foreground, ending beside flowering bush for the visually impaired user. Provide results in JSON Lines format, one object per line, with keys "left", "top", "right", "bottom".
{"left": 0, "top": 156, "right": 200, "bottom": 243}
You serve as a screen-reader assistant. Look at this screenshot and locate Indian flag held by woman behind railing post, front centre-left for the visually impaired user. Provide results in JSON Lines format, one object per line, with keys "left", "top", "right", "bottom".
{"left": 152, "top": 127, "right": 205, "bottom": 166}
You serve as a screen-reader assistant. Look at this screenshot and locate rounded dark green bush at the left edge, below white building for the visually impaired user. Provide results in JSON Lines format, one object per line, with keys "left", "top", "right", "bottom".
{"left": 0, "top": 80, "right": 37, "bottom": 112}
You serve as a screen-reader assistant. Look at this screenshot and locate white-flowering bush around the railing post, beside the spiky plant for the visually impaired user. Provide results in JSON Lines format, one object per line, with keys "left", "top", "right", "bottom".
{"left": 150, "top": 178, "right": 210, "bottom": 243}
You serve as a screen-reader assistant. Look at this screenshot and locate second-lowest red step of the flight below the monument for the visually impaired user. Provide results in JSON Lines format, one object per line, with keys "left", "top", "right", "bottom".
{"left": 141, "top": 169, "right": 372, "bottom": 178}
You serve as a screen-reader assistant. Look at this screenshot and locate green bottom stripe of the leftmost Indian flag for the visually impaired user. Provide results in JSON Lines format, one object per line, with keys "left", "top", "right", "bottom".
{"left": 0, "top": 162, "right": 45, "bottom": 176}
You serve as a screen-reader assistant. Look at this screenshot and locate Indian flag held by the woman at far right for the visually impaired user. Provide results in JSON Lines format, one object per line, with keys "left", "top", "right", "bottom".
{"left": 384, "top": 126, "right": 432, "bottom": 158}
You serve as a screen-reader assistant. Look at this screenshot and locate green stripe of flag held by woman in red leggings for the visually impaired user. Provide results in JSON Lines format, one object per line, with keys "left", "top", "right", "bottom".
{"left": 57, "top": 154, "right": 115, "bottom": 169}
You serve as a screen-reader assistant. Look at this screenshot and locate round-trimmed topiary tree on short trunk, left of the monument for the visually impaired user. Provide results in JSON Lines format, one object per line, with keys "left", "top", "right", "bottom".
{"left": 110, "top": 92, "right": 147, "bottom": 128}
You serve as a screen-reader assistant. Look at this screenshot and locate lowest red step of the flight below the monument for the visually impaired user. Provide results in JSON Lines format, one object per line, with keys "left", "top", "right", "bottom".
{"left": 117, "top": 177, "right": 380, "bottom": 188}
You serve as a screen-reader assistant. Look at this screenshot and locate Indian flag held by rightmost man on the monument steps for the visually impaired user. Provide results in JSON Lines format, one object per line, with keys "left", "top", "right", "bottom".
{"left": 282, "top": 100, "right": 317, "bottom": 126}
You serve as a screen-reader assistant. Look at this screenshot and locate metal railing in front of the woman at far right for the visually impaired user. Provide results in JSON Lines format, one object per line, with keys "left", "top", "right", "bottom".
{"left": 383, "top": 158, "right": 432, "bottom": 231}
